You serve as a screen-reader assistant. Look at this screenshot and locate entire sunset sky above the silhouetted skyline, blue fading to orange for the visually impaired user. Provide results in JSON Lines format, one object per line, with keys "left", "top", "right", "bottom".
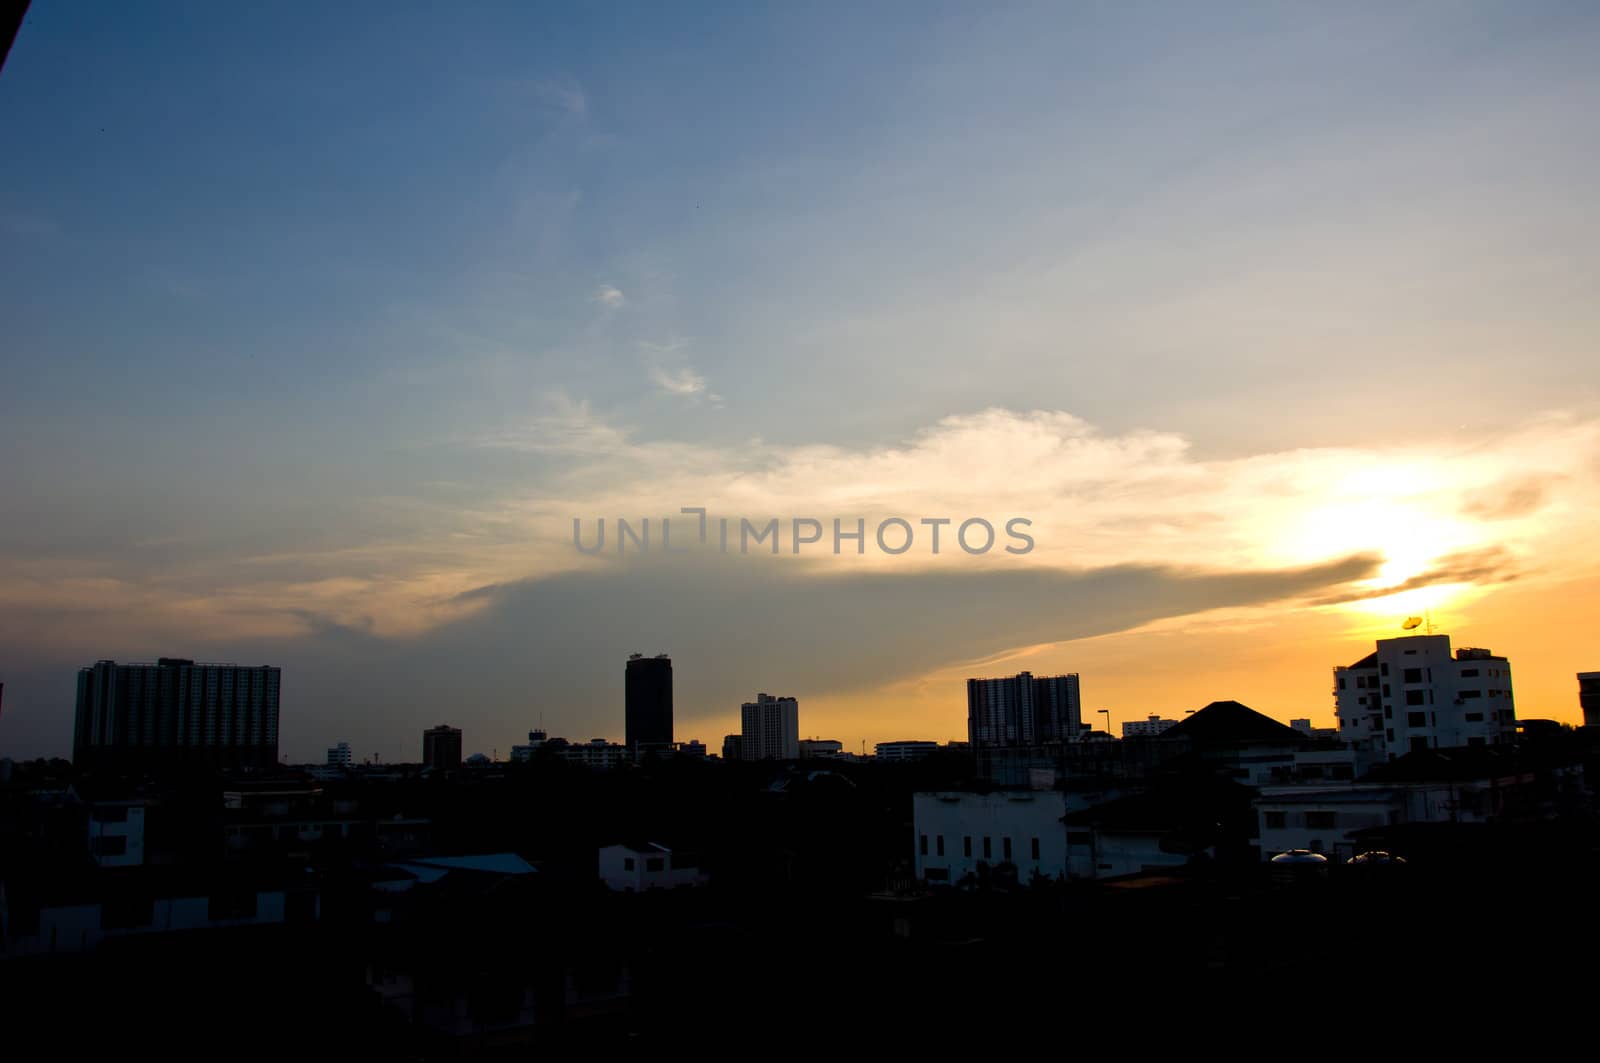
{"left": 0, "top": 0, "right": 1600, "bottom": 762}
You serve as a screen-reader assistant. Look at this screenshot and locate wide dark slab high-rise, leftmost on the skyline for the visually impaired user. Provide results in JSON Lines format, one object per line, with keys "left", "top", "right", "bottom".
{"left": 72, "top": 656, "right": 282, "bottom": 768}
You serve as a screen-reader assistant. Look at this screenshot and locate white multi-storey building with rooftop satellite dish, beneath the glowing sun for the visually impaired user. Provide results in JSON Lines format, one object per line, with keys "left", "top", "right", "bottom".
{"left": 1333, "top": 636, "right": 1517, "bottom": 760}
